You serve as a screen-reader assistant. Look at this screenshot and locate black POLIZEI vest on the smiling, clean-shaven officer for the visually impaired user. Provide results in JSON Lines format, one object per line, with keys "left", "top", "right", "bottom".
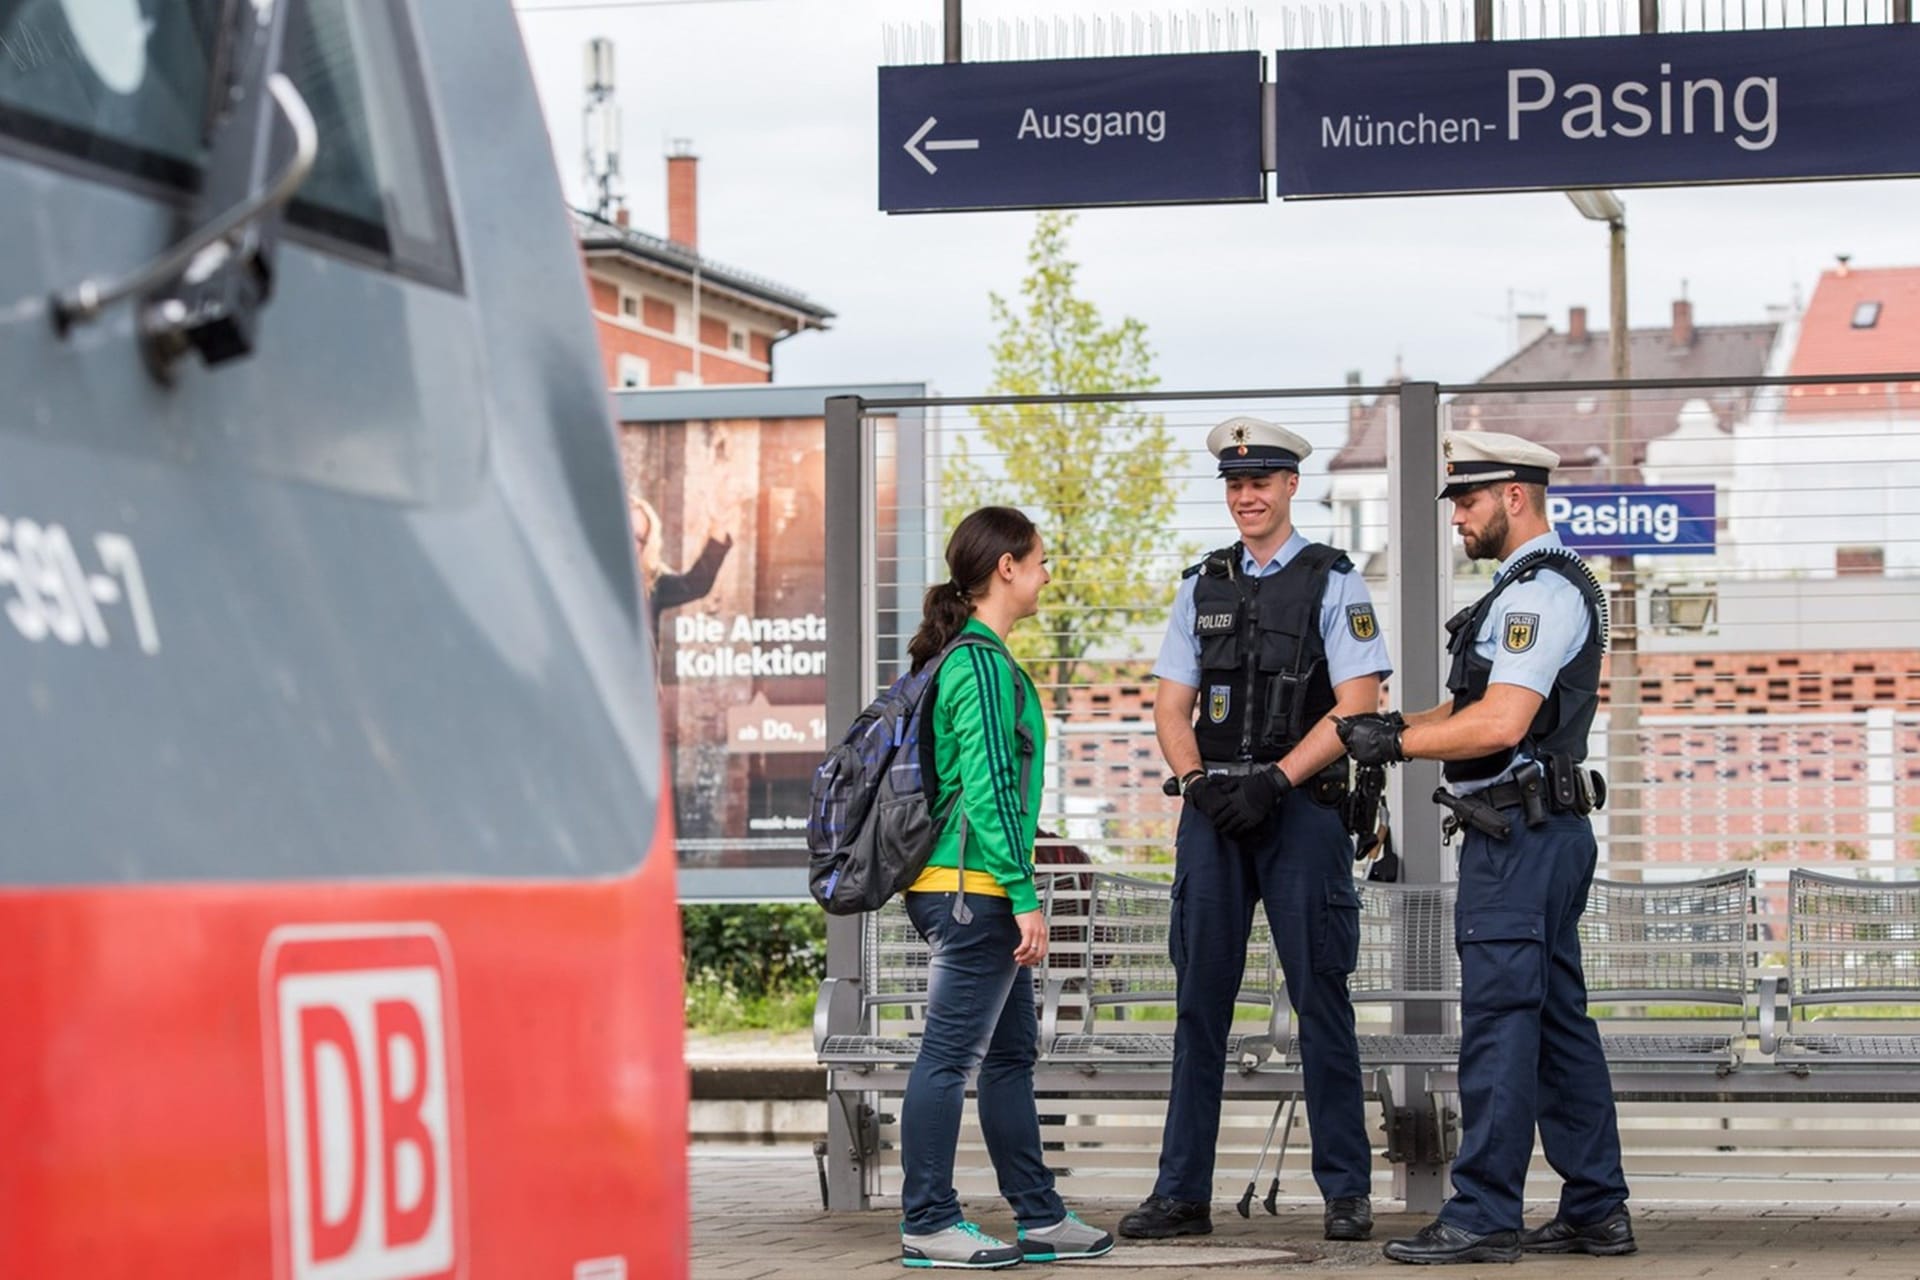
{"left": 1185, "top": 543, "right": 1354, "bottom": 762}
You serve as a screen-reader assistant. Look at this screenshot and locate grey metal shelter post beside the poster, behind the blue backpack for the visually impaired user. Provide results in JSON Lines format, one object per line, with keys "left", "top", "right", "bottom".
{"left": 826, "top": 395, "right": 868, "bottom": 1209}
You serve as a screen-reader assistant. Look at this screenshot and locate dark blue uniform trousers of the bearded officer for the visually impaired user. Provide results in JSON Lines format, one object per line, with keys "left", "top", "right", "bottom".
{"left": 1440, "top": 810, "right": 1626, "bottom": 1234}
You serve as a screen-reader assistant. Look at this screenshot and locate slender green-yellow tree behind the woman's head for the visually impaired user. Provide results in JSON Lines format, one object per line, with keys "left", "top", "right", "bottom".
{"left": 945, "top": 211, "right": 1181, "bottom": 712}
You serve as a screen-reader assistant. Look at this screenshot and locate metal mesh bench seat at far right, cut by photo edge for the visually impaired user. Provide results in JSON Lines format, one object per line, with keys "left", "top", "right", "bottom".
{"left": 1761, "top": 869, "right": 1920, "bottom": 1100}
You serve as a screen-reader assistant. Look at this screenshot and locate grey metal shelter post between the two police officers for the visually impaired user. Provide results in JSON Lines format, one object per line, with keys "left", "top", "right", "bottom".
{"left": 1386, "top": 382, "right": 1452, "bottom": 1213}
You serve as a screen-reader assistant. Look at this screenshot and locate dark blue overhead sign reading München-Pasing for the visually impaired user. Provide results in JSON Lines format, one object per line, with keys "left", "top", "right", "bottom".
{"left": 1273, "top": 25, "right": 1920, "bottom": 198}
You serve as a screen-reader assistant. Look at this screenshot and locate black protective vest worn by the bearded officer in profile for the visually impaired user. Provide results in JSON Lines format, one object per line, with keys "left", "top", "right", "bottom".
{"left": 1444, "top": 547, "right": 1607, "bottom": 783}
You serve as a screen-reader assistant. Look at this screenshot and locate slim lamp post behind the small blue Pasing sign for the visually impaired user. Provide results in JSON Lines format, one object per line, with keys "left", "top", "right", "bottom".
{"left": 1607, "top": 217, "right": 1645, "bottom": 879}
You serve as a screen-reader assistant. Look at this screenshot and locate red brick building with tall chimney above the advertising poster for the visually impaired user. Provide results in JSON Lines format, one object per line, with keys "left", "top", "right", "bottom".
{"left": 572, "top": 146, "right": 833, "bottom": 388}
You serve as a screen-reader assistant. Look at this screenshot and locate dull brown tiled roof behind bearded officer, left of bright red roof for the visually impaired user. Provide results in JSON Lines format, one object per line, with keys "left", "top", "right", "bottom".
{"left": 1331, "top": 324, "right": 1778, "bottom": 484}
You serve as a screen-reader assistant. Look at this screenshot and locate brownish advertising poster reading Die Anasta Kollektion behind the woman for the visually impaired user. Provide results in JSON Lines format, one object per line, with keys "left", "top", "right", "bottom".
{"left": 620, "top": 418, "right": 893, "bottom": 867}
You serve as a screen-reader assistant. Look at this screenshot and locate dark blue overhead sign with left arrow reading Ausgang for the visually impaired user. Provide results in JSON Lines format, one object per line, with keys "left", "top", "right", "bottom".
{"left": 879, "top": 52, "right": 1267, "bottom": 213}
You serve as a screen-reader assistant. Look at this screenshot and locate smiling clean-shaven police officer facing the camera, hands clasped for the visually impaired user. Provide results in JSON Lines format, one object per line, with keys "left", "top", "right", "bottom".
{"left": 1119, "top": 416, "right": 1390, "bottom": 1240}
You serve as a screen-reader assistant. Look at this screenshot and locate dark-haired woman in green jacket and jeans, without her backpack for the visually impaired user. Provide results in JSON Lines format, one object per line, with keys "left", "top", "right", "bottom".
{"left": 900, "top": 507, "right": 1114, "bottom": 1268}
